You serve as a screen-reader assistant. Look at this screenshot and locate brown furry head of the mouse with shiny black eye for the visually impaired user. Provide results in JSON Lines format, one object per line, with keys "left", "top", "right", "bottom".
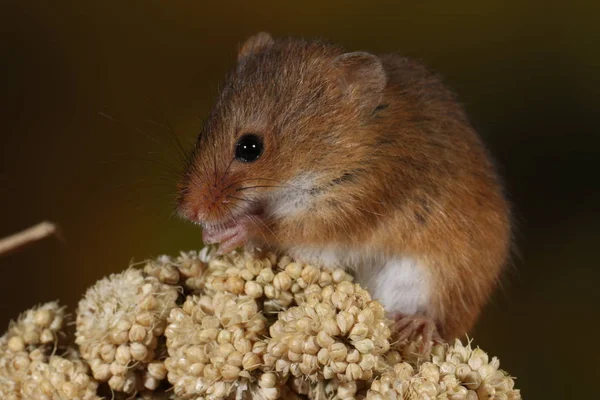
{"left": 179, "top": 33, "right": 386, "bottom": 239}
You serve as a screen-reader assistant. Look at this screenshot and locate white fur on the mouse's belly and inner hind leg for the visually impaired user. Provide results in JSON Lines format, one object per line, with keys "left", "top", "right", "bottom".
{"left": 290, "top": 247, "right": 431, "bottom": 315}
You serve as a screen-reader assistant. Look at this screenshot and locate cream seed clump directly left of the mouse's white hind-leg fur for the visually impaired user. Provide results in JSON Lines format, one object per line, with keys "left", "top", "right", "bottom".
{"left": 265, "top": 281, "right": 390, "bottom": 382}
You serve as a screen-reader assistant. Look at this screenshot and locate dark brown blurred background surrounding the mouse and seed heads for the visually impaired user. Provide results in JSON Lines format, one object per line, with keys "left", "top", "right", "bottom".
{"left": 0, "top": 0, "right": 600, "bottom": 399}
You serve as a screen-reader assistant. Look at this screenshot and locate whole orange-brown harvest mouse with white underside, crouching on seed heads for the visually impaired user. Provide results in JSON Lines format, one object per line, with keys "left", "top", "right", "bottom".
{"left": 179, "top": 33, "right": 511, "bottom": 346}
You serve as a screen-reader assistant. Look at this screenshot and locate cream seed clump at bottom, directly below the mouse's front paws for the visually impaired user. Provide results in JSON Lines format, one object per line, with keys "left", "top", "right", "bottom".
{"left": 165, "top": 292, "right": 279, "bottom": 398}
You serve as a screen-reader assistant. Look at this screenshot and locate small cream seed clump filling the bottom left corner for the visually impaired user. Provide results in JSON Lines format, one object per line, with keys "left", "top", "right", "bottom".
{"left": 0, "top": 302, "right": 99, "bottom": 400}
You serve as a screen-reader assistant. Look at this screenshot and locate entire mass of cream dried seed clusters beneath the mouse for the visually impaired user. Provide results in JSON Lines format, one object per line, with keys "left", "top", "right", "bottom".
{"left": 0, "top": 247, "right": 521, "bottom": 400}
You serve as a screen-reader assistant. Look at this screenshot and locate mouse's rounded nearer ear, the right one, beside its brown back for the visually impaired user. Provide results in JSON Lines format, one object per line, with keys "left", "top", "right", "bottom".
{"left": 334, "top": 52, "right": 387, "bottom": 112}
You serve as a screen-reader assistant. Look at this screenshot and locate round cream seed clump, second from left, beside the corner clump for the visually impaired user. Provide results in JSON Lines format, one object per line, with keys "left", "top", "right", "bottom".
{"left": 75, "top": 269, "right": 179, "bottom": 393}
